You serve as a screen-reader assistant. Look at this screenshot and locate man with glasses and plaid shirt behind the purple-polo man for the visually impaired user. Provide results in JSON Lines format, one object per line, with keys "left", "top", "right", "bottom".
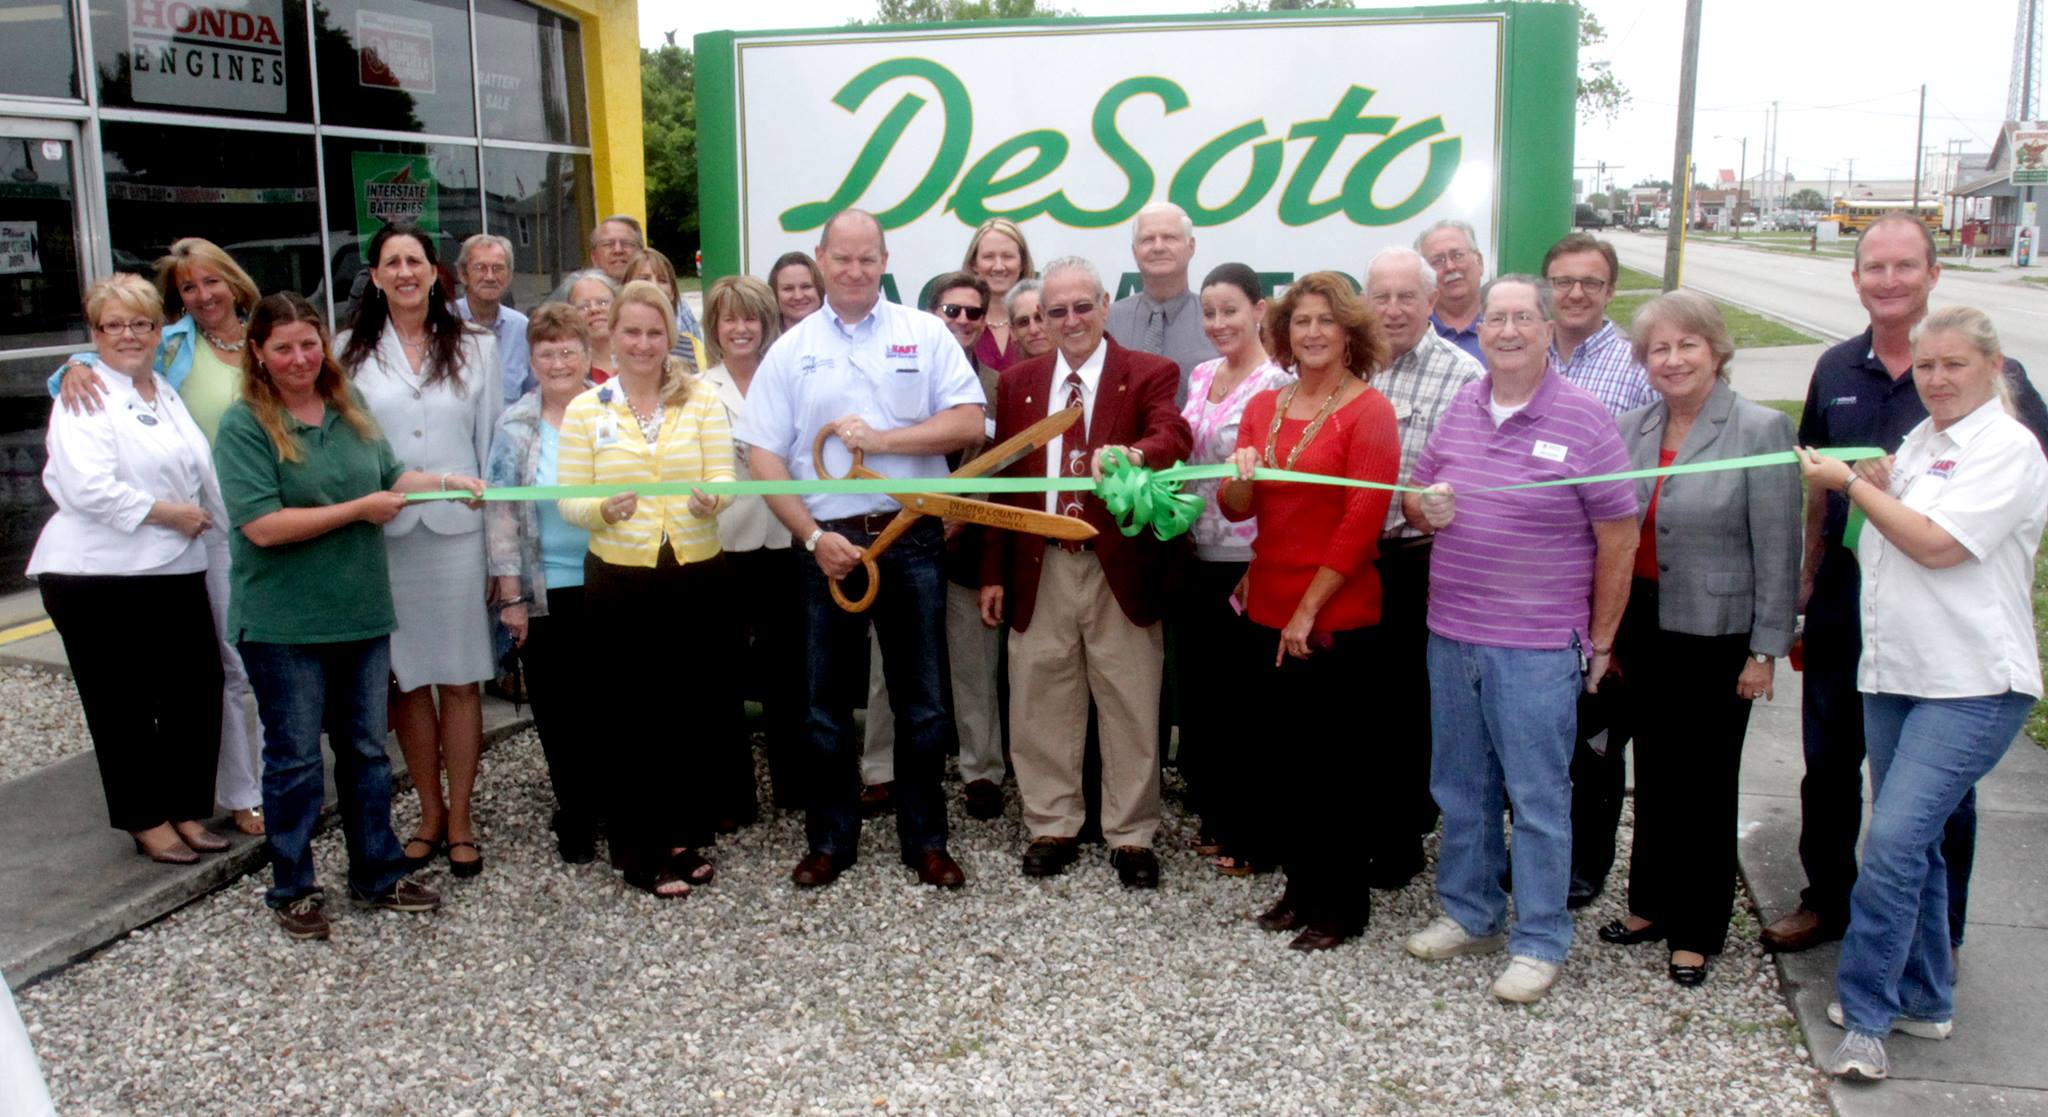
{"left": 1542, "top": 234, "right": 1657, "bottom": 908}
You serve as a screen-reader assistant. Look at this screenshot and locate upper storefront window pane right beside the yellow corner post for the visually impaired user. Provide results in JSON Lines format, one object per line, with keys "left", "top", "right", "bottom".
{"left": 477, "top": 0, "right": 588, "bottom": 143}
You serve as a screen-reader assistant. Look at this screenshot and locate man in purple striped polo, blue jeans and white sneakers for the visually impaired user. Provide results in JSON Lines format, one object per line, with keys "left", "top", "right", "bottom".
{"left": 1401, "top": 275, "right": 1636, "bottom": 1004}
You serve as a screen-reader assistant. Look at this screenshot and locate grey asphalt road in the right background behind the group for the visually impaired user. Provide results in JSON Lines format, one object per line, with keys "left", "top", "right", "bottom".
{"left": 1612, "top": 232, "right": 2048, "bottom": 391}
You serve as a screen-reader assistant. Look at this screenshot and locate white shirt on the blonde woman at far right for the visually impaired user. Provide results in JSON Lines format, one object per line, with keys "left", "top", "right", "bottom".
{"left": 1855, "top": 400, "right": 2048, "bottom": 699}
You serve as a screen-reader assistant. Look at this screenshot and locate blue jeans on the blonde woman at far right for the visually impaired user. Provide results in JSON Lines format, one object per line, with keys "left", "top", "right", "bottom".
{"left": 1835, "top": 691, "right": 2034, "bottom": 1035}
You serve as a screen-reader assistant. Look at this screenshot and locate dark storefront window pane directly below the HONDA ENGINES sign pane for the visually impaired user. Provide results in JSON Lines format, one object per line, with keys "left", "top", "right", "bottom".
{"left": 100, "top": 123, "right": 326, "bottom": 297}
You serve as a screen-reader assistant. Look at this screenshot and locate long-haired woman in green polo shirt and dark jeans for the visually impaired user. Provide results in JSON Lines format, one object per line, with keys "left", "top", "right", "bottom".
{"left": 213, "top": 293, "right": 483, "bottom": 939}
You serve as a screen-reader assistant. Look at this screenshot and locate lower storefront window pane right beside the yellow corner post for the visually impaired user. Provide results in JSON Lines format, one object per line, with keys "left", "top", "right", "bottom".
{"left": 483, "top": 148, "right": 594, "bottom": 309}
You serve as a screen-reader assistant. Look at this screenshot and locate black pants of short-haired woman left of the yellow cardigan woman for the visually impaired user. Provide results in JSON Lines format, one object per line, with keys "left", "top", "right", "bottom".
{"left": 518, "top": 586, "right": 610, "bottom": 836}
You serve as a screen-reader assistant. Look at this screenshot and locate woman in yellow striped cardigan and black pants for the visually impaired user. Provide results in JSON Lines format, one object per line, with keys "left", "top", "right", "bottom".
{"left": 555, "top": 281, "right": 741, "bottom": 900}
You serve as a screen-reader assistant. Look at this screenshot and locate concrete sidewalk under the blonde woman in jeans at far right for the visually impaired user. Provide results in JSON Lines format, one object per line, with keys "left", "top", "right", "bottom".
{"left": 1736, "top": 664, "right": 2048, "bottom": 1117}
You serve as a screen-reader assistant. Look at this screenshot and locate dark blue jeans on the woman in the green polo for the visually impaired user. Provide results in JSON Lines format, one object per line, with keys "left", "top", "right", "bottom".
{"left": 240, "top": 635, "right": 406, "bottom": 908}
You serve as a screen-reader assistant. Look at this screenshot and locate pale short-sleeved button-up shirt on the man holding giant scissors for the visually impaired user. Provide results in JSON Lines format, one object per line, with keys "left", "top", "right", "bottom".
{"left": 733, "top": 299, "right": 987, "bottom": 521}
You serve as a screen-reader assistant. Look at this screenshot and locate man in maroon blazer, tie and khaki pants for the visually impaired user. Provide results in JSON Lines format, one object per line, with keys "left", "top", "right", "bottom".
{"left": 981, "top": 256, "right": 1194, "bottom": 887}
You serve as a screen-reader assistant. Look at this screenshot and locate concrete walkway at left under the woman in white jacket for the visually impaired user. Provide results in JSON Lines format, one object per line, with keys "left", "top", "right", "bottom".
{"left": 0, "top": 592, "right": 532, "bottom": 988}
